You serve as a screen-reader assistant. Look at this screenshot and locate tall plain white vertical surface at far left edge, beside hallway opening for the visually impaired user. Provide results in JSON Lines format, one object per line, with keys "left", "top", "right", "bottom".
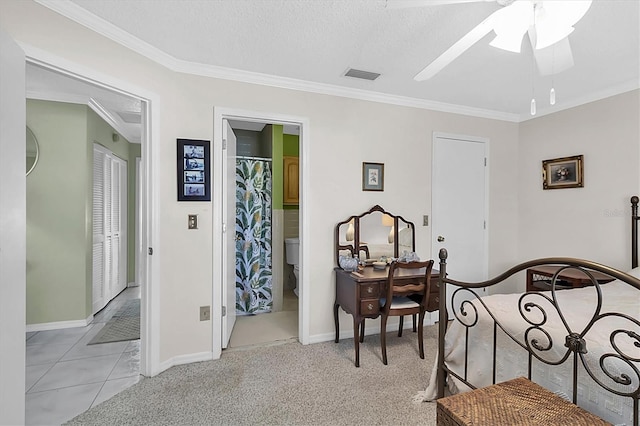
{"left": 0, "top": 28, "right": 27, "bottom": 425}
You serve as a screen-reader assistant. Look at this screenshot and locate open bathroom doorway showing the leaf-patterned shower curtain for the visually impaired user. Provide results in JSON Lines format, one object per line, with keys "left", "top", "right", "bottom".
{"left": 226, "top": 120, "right": 300, "bottom": 348}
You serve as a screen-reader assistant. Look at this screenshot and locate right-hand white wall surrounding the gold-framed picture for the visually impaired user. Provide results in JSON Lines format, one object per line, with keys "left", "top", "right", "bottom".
{"left": 518, "top": 90, "right": 640, "bottom": 276}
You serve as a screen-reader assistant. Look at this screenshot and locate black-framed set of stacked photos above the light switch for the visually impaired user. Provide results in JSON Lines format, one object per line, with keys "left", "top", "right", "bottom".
{"left": 177, "top": 139, "right": 211, "bottom": 201}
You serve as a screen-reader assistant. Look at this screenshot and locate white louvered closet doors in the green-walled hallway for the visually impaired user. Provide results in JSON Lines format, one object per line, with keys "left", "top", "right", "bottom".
{"left": 92, "top": 144, "right": 127, "bottom": 314}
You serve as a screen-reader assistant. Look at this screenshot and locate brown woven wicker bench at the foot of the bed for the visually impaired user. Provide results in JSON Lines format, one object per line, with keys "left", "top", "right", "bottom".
{"left": 437, "top": 377, "right": 610, "bottom": 426}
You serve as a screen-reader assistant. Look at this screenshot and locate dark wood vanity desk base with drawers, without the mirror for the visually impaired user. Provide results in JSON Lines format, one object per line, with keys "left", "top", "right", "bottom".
{"left": 333, "top": 266, "right": 440, "bottom": 367}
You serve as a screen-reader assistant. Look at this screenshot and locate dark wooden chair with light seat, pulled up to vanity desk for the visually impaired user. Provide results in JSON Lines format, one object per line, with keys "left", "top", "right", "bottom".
{"left": 380, "top": 260, "right": 433, "bottom": 365}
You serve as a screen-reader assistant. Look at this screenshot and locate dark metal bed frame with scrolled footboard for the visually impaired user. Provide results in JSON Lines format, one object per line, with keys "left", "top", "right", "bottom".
{"left": 437, "top": 196, "right": 640, "bottom": 426}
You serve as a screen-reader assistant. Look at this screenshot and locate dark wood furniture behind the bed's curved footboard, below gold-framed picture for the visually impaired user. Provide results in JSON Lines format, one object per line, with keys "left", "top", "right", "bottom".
{"left": 527, "top": 265, "right": 614, "bottom": 291}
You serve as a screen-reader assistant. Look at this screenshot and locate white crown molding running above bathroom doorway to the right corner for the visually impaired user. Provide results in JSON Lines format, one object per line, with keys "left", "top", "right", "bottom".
{"left": 35, "top": 0, "right": 520, "bottom": 122}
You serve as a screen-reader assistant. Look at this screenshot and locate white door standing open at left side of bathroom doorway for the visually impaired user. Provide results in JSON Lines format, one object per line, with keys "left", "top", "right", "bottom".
{"left": 222, "top": 120, "right": 236, "bottom": 349}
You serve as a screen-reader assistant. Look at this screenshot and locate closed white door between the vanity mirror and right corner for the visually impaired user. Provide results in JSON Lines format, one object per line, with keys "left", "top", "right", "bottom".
{"left": 431, "top": 135, "right": 488, "bottom": 314}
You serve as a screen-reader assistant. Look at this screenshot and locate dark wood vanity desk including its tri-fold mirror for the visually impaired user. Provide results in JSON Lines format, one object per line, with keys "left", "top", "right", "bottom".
{"left": 333, "top": 205, "right": 439, "bottom": 367}
